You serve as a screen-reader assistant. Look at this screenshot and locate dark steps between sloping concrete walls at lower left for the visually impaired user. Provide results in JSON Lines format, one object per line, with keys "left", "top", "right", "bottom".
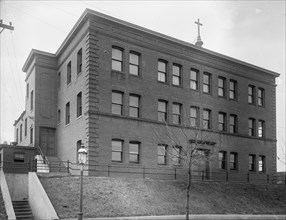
{"left": 12, "top": 200, "right": 34, "bottom": 220}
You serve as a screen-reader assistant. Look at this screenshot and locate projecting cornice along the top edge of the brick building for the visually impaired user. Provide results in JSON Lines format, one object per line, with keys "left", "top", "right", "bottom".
{"left": 23, "top": 8, "right": 280, "bottom": 77}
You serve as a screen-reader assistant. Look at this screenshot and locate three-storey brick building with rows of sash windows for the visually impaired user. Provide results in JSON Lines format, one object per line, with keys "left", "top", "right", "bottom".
{"left": 14, "top": 9, "right": 279, "bottom": 180}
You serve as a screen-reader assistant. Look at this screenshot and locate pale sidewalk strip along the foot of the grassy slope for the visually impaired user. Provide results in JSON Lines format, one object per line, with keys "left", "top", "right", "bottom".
{"left": 63, "top": 215, "right": 286, "bottom": 220}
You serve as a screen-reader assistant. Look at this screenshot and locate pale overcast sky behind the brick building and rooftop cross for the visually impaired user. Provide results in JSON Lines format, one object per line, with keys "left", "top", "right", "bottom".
{"left": 0, "top": 0, "right": 286, "bottom": 170}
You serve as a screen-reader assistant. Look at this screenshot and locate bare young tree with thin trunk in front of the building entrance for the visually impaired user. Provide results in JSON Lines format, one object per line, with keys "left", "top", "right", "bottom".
{"left": 154, "top": 123, "right": 215, "bottom": 220}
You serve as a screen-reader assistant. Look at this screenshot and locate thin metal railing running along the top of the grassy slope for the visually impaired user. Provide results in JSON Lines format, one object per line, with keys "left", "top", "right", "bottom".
{"left": 2, "top": 161, "right": 286, "bottom": 185}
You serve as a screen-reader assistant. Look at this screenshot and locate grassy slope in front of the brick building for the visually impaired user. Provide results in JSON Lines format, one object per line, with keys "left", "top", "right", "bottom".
{"left": 40, "top": 177, "right": 286, "bottom": 218}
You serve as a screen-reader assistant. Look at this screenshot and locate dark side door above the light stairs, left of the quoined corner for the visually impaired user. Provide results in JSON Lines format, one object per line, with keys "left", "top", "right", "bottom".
{"left": 40, "top": 127, "right": 56, "bottom": 156}
